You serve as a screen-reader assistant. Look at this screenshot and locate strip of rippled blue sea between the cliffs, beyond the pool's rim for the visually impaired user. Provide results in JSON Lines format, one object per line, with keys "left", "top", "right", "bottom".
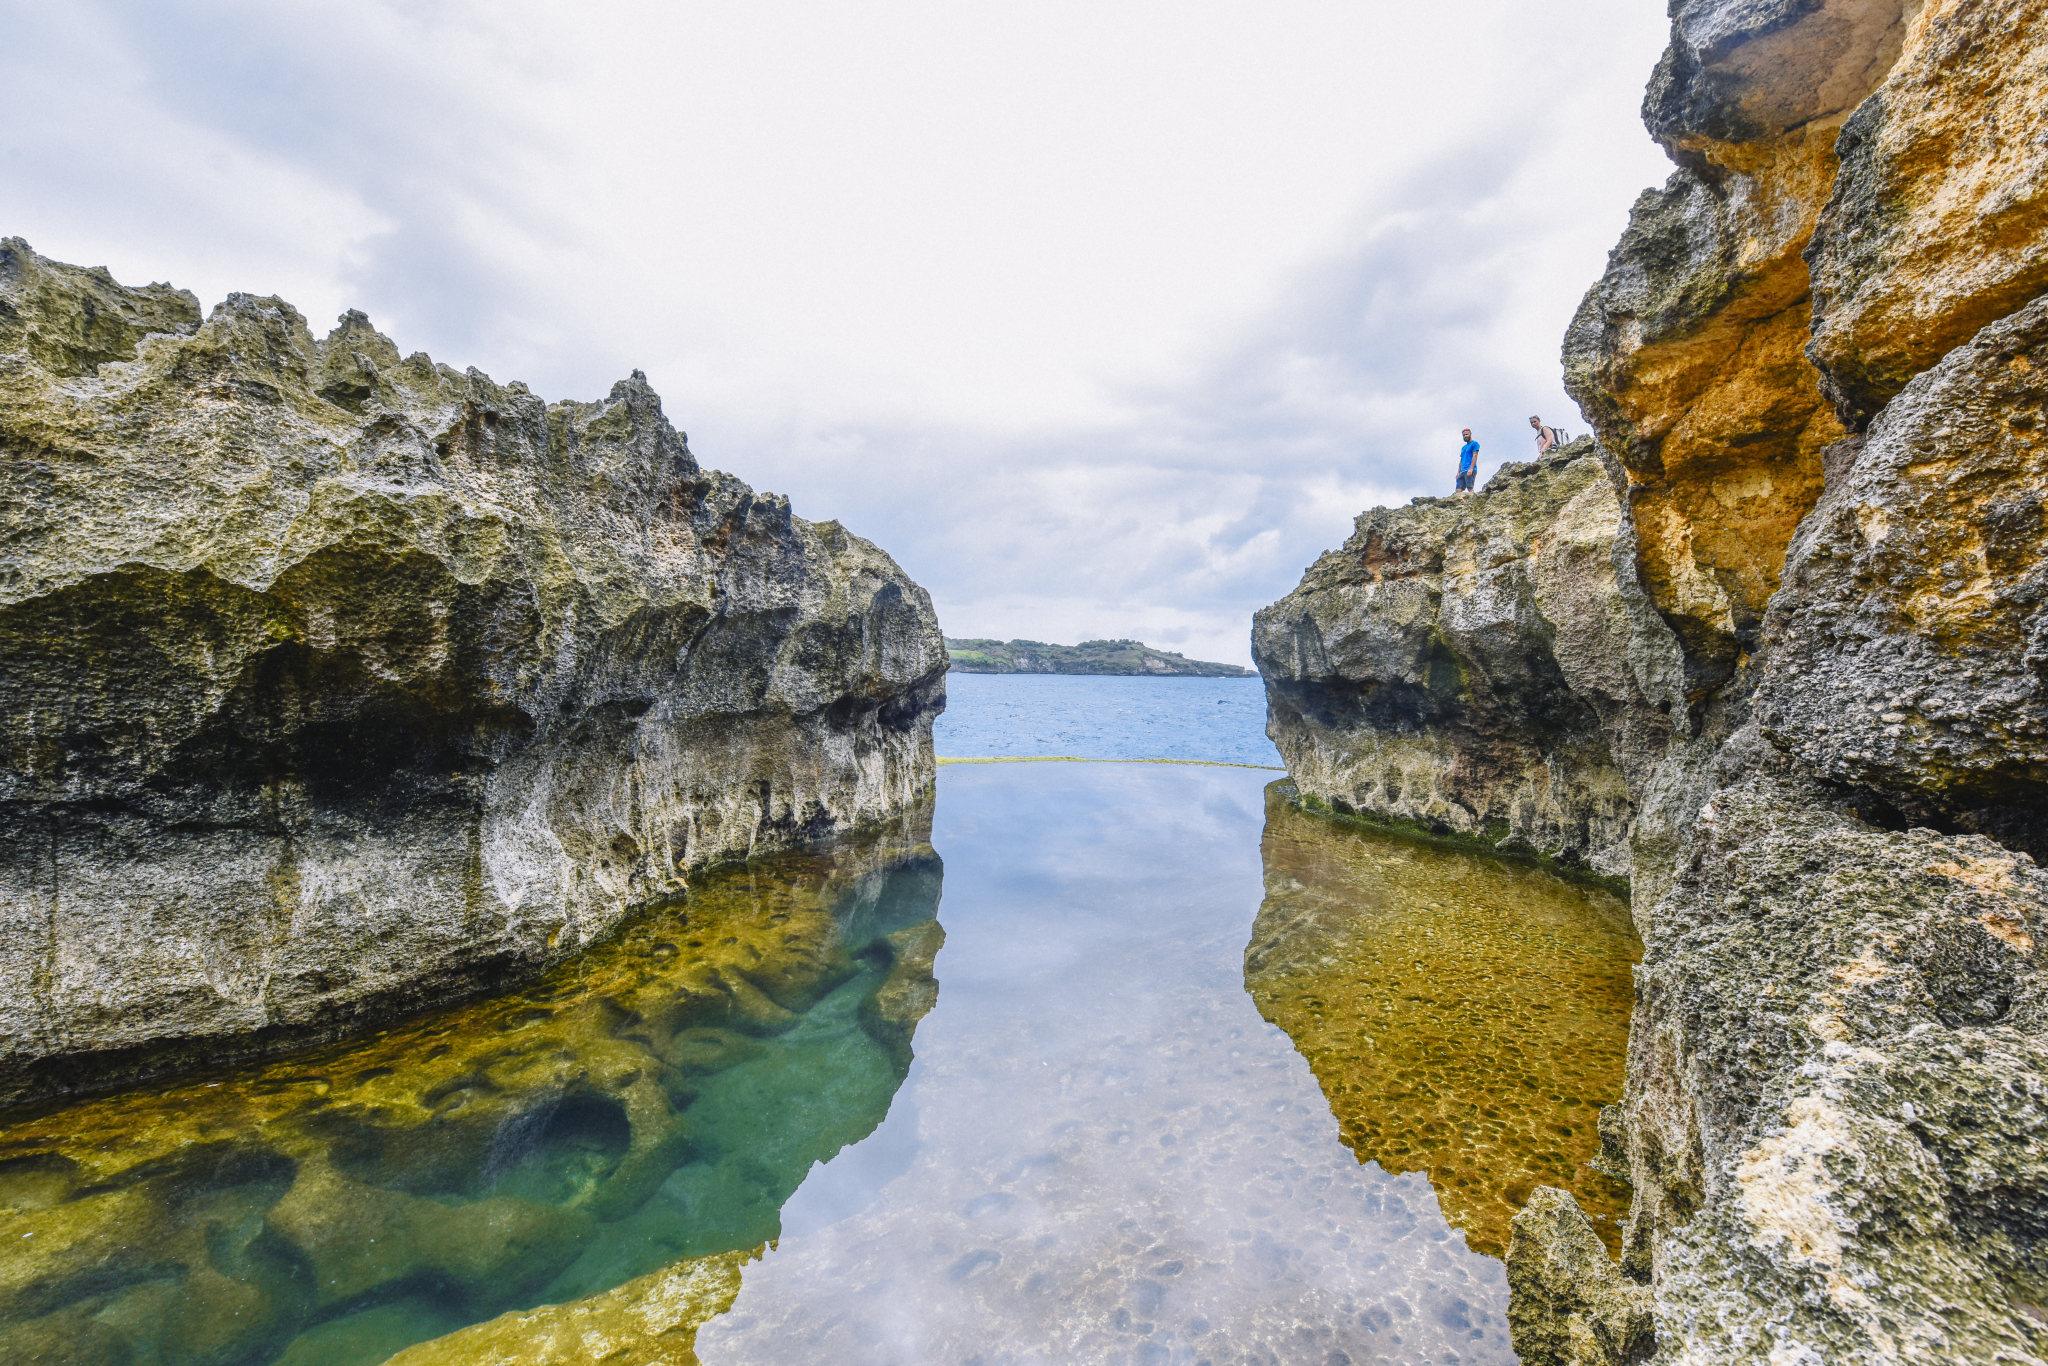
{"left": 932, "top": 674, "right": 1280, "bottom": 768}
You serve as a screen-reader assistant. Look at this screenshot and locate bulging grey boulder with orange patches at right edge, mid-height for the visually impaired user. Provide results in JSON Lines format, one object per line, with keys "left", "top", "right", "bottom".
{"left": 1757, "top": 299, "right": 2048, "bottom": 858}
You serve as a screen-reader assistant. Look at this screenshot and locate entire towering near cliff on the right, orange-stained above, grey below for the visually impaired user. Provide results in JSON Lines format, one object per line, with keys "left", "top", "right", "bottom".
{"left": 1262, "top": 0, "right": 2048, "bottom": 1366}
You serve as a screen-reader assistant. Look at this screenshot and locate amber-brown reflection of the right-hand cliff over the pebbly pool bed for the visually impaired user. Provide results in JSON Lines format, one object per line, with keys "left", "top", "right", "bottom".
{"left": 1245, "top": 782, "right": 1642, "bottom": 1255}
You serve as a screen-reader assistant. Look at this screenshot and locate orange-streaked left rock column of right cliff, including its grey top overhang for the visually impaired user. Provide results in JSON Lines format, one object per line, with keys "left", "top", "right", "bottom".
{"left": 1565, "top": 0, "right": 1933, "bottom": 688}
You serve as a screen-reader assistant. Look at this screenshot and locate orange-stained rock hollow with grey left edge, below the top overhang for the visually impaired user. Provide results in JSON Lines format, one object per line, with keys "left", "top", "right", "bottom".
{"left": 1565, "top": 139, "right": 1843, "bottom": 700}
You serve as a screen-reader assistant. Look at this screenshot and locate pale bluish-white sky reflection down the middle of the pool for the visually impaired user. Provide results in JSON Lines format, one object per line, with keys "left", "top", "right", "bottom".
{"left": 696, "top": 764, "right": 1513, "bottom": 1366}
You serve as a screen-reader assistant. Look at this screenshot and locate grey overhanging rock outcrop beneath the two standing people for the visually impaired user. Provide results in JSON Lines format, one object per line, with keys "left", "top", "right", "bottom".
{"left": 1251, "top": 440, "right": 1686, "bottom": 874}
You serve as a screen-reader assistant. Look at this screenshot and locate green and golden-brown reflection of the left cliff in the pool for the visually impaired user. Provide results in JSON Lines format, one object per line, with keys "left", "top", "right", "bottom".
{"left": 0, "top": 807, "right": 942, "bottom": 1366}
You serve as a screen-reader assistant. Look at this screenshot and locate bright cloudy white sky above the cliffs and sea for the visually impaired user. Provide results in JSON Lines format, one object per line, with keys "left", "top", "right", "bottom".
{"left": 0, "top": 0, "right": 1669, "bottom": 664}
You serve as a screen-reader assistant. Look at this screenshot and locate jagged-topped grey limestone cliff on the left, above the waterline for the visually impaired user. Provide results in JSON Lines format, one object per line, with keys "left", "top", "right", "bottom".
{"left": 0, "top": 240, "right": 946, "bottom": 1098}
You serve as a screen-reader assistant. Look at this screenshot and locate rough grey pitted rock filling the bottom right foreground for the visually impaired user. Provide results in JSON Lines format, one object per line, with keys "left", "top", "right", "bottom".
{"left": 1624, "top": 774, "right": 2048, "bottom": 1366}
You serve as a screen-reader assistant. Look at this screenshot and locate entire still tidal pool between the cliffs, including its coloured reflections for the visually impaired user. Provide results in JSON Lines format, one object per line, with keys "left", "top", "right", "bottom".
{"left": 0, "top": 764, "right": 1628, "bottom": 1366}
